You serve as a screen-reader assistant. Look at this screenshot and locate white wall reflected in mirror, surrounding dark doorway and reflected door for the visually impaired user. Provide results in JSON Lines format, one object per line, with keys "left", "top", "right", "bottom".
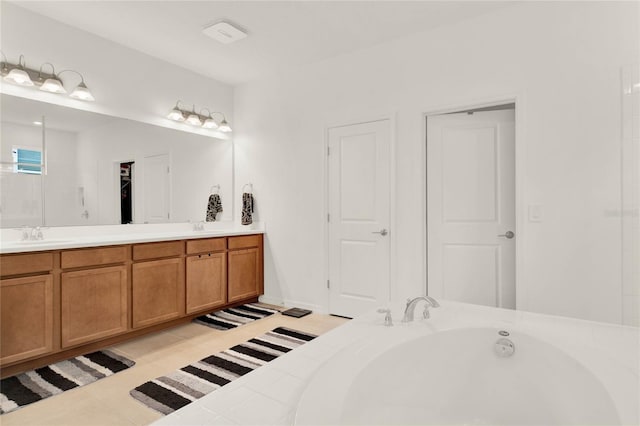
{"left": 78, "top": 119, "right": 233, "bottom": 225}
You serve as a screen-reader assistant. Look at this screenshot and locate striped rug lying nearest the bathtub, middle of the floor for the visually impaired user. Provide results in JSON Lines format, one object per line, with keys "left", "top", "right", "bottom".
{"left": 129, "top": 327, "right": 317, "bottom": 414}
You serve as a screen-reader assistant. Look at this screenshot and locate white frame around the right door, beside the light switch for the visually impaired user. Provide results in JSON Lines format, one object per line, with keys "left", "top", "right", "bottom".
{"left": 421, "top": 94, "right": 527, "bottom": 310}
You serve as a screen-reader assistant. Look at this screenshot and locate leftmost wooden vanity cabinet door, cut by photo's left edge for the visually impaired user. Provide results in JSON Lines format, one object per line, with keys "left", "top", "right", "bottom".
{"left": 0, "top": 274, "right": 53, "bottom": 364}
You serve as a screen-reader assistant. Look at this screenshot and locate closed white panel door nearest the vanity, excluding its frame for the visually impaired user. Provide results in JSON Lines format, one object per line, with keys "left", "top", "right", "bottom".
{"left": 328, "top": 120, "right": 391, "bottom": 317}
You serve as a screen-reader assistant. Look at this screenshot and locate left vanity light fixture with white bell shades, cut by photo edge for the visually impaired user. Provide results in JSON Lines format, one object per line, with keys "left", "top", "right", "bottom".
{"left": 0, "top": 53, "right": 95, "bottom": 101}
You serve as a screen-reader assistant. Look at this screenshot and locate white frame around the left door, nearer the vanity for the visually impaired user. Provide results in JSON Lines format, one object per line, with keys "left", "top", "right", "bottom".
{"left": 322, "top": 111, "right": 398, "bottom": 313}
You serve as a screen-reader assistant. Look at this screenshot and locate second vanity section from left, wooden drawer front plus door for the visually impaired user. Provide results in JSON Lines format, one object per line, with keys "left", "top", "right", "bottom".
{"left": 60, "top": 246, "right": 128, "bottom": 348}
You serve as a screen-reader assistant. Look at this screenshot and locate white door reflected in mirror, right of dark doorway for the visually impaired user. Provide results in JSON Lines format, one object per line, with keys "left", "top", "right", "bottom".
{"left": 143, "top": 154, "right": 171, "bottom": 223}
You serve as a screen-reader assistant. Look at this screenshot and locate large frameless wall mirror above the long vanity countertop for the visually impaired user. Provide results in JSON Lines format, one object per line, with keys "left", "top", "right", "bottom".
{"left": 0, "top": 94, "right": 233, "bottom": 228}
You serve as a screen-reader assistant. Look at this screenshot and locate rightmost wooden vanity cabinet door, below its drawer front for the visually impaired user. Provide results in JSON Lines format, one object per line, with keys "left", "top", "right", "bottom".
{"left": 228, "top": 247, "right": 262, "bottom": 303}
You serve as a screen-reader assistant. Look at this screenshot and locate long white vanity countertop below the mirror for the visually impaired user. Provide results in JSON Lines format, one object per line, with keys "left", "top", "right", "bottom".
{"left": 0, "top": 222, "right": 264, "bottom": 254}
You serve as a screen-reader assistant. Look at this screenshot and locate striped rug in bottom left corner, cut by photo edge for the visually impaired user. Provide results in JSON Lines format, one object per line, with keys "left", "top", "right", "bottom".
{"left": 0, "top": 351, "right": 135, "bottom": 414}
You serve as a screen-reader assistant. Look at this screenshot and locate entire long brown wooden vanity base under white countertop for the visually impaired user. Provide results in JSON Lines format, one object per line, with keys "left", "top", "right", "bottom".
{"left": 0, "top": 234, "right": 263, "bottom": 377}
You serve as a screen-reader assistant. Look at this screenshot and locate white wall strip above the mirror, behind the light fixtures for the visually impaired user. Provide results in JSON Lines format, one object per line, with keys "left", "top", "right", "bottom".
{"left": 0, "top": 1, "right": 234, "bottom": 139}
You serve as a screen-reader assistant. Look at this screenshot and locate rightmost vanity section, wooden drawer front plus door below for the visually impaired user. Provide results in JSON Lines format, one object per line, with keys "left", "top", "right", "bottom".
{"left": 227, "top": 235, "right": 263, "bottom": 303}
